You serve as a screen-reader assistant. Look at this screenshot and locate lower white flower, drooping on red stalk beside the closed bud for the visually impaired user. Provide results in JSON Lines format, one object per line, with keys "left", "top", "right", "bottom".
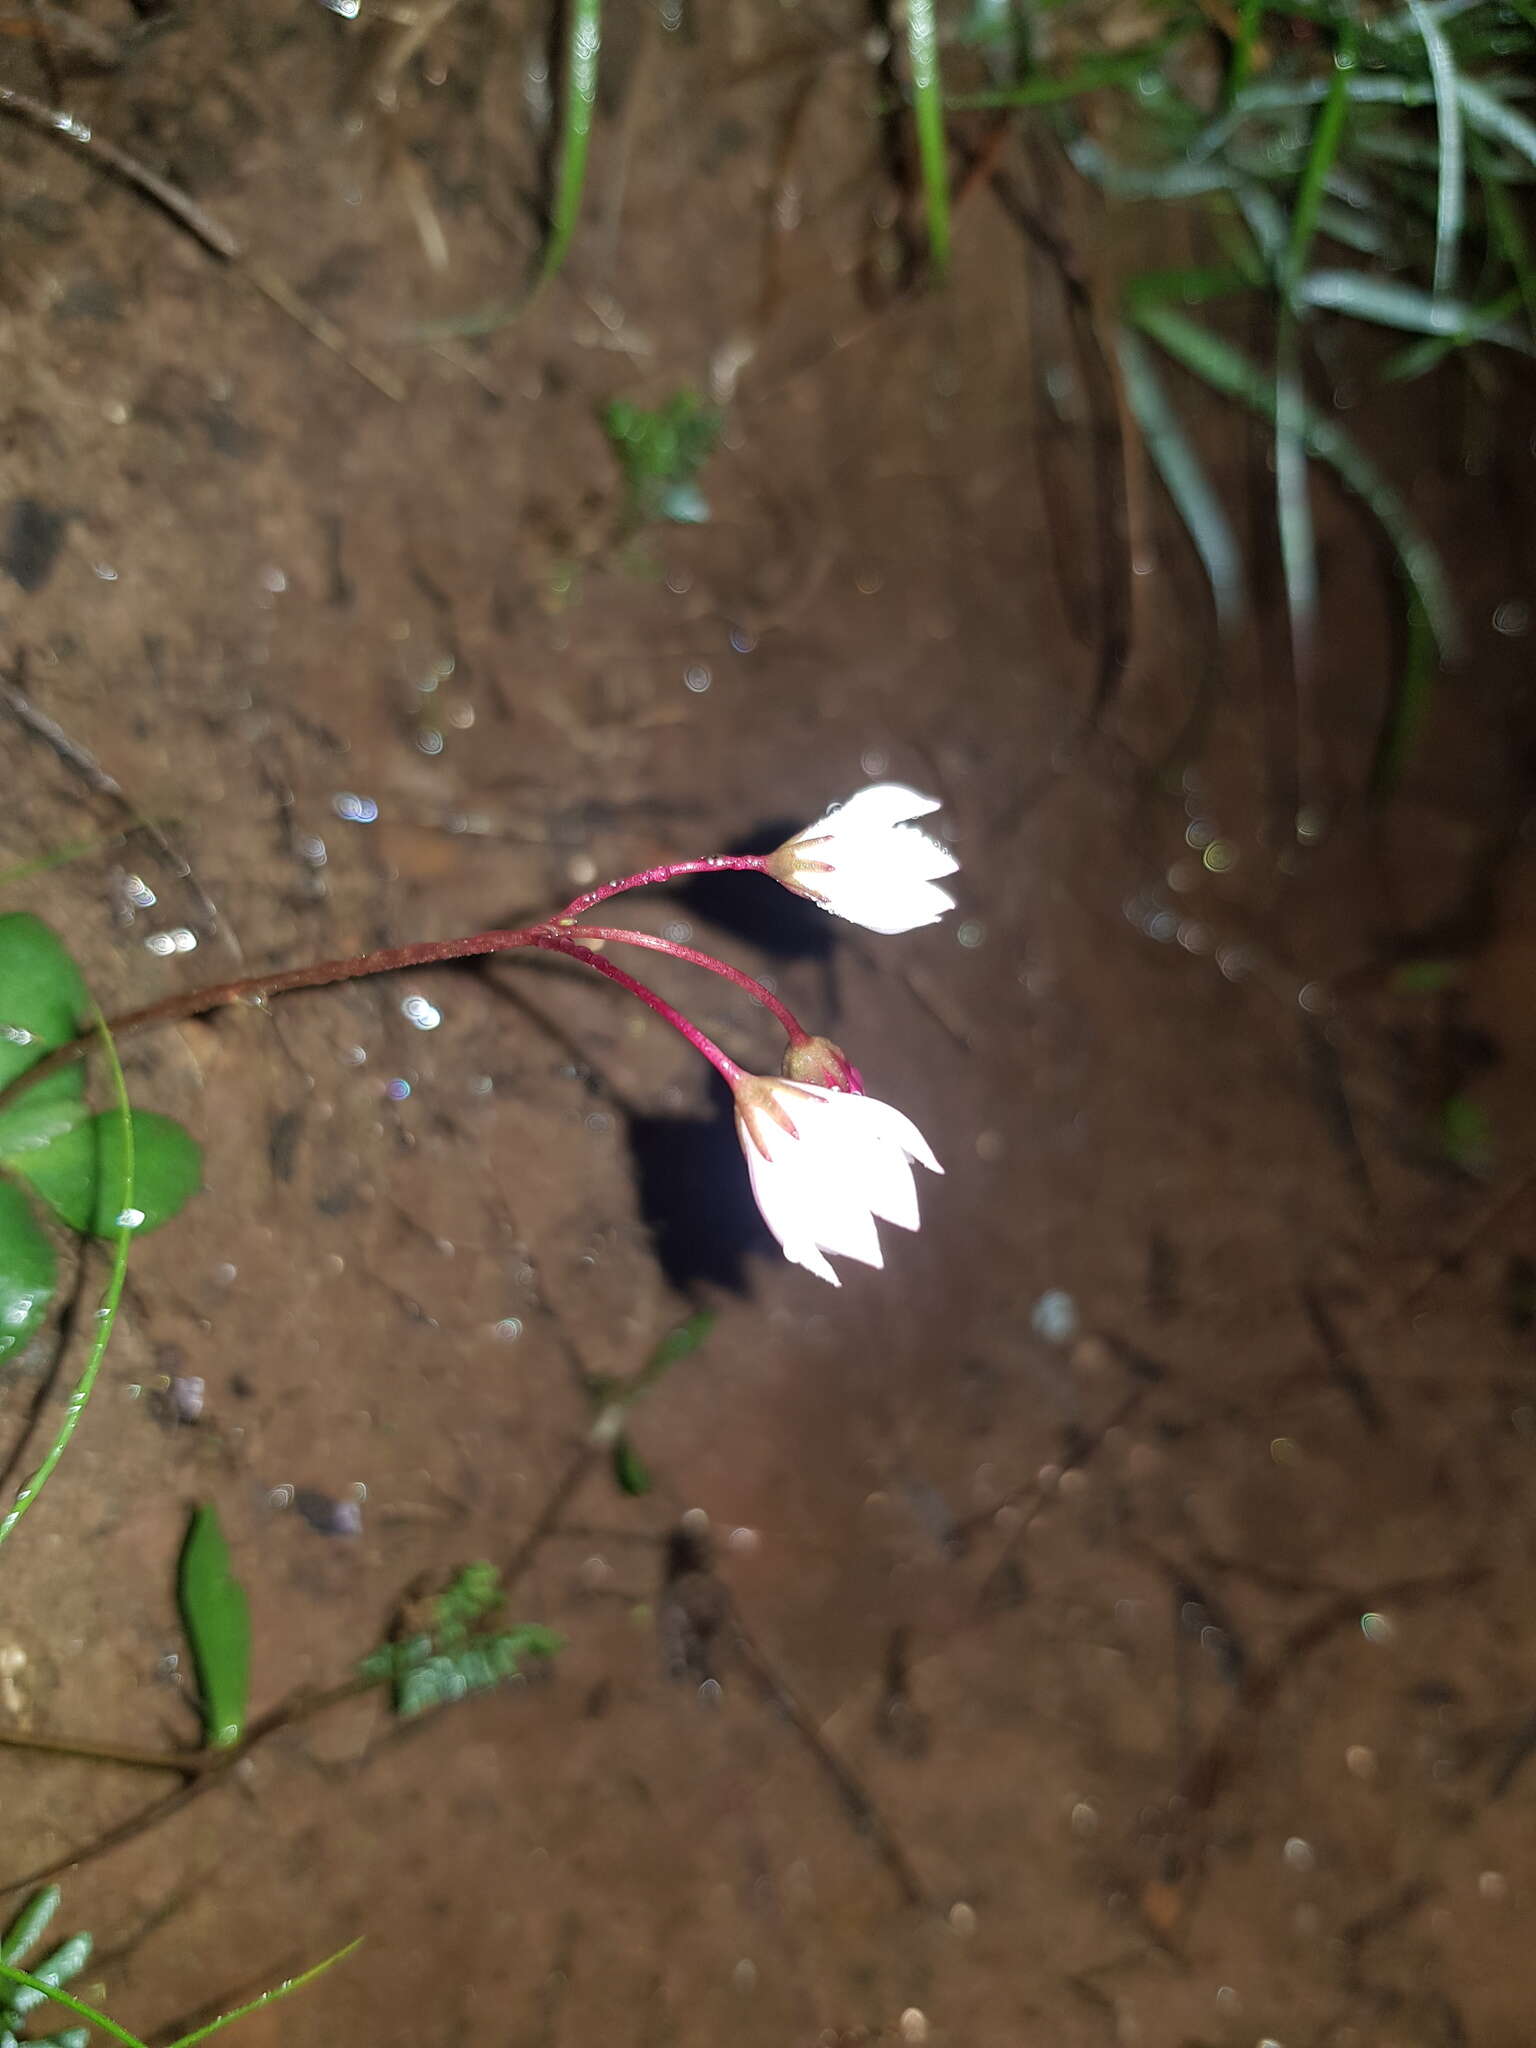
{"left": 735, "top": 1073, "right": 944, "bottom": 1286}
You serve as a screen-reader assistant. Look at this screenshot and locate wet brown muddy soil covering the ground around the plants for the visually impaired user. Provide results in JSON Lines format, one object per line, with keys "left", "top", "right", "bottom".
{"left": 0, "top": 0, "right": 1536, "bottom": 2048}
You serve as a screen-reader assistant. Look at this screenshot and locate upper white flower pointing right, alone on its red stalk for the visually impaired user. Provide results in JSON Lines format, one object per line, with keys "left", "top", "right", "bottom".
{"left": 768, "top": 782, "right": 958, "bottom": 932}
